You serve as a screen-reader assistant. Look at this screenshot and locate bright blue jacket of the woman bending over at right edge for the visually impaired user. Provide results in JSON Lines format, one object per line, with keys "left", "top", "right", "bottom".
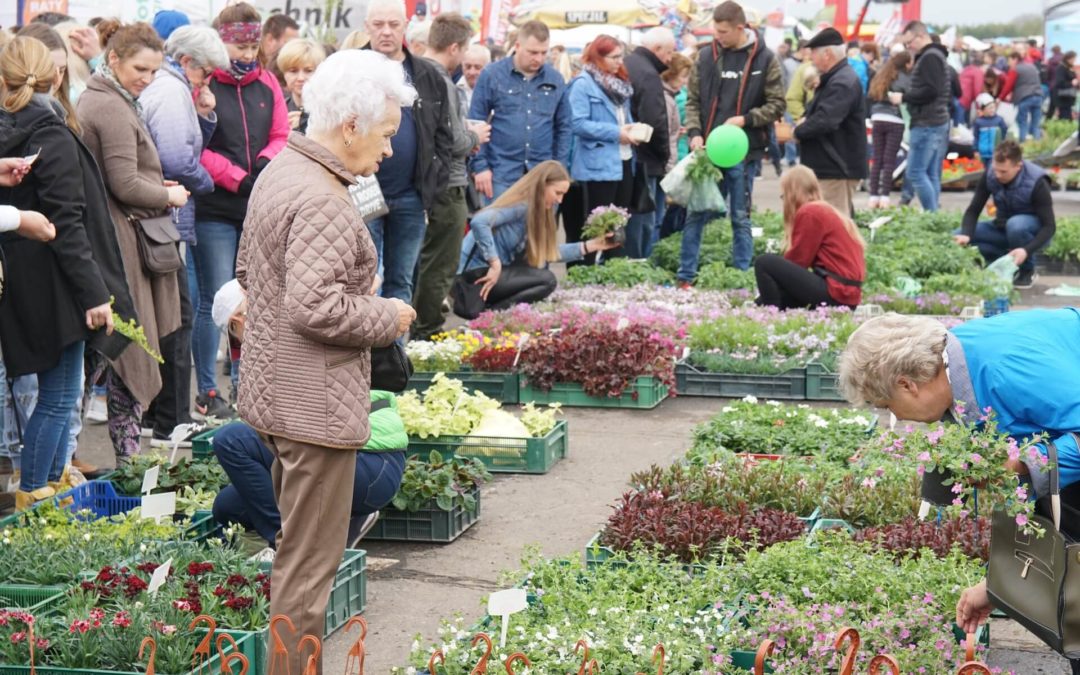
{"left": 948, "top": 308, "right": 1080, "bottom": 496}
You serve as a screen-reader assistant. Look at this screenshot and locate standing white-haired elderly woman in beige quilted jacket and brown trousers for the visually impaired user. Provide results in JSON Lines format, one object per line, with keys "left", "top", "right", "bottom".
{"left": 237, "top": 50, "right": 416, "bottom": 673}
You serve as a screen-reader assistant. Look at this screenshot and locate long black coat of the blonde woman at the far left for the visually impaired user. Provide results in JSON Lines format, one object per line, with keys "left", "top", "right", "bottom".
{"left": 0, "top": 95, "right": 135, "bottom": 377}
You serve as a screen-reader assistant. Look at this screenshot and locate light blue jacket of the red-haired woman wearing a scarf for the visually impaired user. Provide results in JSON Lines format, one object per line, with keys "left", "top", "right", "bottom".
{"left": 566, "top": 72, "right": 634, "bottom": 180}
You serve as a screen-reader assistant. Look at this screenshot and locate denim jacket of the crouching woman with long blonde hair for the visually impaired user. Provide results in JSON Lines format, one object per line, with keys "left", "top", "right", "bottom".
{"left": 458, "top": 203, "right": 581, "bottom": 274}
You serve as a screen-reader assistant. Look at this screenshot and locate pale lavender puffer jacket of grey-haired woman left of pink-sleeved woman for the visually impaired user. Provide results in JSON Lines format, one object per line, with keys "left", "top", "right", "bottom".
{"left": 138, "top": 58, "right": 217, "bottom": 244}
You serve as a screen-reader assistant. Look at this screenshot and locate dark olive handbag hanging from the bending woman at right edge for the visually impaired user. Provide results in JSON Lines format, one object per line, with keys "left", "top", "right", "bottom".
{"left": 986, "top": 433, "right": 1080, "bottom": 659}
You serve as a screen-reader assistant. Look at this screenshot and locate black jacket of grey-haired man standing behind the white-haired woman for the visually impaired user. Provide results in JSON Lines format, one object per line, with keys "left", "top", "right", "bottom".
{"left": 364, "top": 44, "right": 454, "bottom": 211}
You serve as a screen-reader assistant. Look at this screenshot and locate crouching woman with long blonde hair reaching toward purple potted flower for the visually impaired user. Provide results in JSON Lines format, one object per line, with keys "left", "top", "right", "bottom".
{"left": 455, "top": 160, "right": 620, "bottom": 319}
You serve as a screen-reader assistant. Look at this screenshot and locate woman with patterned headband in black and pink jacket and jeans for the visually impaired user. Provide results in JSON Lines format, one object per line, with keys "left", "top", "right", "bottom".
{"left": 191, "top": 2, "right": 289, "bottom": 418}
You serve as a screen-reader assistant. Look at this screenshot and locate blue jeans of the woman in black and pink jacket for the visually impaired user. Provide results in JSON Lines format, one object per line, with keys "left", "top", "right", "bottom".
{"left": 191, "top": 220, "right": 240, "bottom": 395}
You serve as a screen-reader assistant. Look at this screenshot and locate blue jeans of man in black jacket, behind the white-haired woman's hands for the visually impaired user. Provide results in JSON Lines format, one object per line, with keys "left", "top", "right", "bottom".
{"left": 367, "top": 191, "right": 428, "bottom": 302}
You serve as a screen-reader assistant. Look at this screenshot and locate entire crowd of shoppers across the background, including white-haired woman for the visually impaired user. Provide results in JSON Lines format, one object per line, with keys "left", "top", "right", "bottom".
{"left": 0, "top": 0, "right": 1076, "bottom": 667}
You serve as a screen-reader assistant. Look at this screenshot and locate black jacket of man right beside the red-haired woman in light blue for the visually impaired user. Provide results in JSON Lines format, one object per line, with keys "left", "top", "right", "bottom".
{"left": 624, "top": 46, "right": 671, "bottom": 176}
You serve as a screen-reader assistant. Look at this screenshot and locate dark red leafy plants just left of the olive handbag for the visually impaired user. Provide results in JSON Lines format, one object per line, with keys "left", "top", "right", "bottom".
{"left": 855, "top": 517, "right": 990, "bottom": 562}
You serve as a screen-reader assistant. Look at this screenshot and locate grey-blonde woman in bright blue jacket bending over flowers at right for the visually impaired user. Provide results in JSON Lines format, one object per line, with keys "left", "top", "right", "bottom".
{"left": 839, "top": 308, "right": 1080, "bottom": 673}
